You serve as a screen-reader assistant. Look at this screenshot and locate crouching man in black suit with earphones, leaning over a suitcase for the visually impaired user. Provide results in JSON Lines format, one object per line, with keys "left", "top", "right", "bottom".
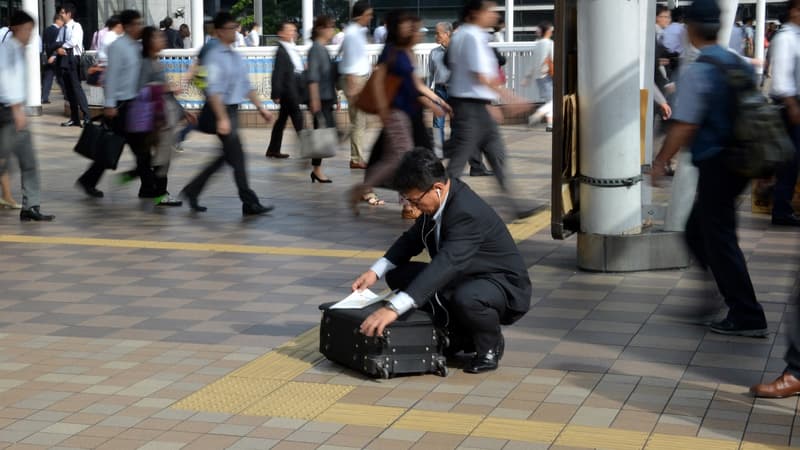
{"left": 352, "top": 149, "right": 532, "bottom": 373}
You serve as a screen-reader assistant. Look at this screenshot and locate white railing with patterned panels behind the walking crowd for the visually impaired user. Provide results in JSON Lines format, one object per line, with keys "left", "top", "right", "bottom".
{"left": 84, "top": 42, "right": 539, "bottom": 109}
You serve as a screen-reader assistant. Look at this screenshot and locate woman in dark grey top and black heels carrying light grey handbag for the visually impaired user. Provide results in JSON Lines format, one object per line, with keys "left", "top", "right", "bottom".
{"left": 306, "top": 16, "right": 336, "bottom": 183}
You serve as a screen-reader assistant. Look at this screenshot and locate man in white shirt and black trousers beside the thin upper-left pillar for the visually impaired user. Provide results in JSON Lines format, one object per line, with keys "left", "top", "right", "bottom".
{"left": 56, "top": 3, "right": 89, "bottom": 127}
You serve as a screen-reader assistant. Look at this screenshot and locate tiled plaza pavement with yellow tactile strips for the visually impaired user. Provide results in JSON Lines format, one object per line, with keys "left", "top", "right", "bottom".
{"left": 0, "top": 103, "right": 800, "bottom": 450}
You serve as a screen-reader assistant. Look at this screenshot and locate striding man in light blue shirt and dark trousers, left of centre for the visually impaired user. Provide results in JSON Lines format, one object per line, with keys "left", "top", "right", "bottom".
{"left": 181, "top": 11, "right": 273, "bottom": 216}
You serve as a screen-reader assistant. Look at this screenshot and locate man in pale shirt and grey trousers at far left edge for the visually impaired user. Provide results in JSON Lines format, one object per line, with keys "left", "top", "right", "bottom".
{"left": 0, "top": 10, "right": 55, "bottom": 222}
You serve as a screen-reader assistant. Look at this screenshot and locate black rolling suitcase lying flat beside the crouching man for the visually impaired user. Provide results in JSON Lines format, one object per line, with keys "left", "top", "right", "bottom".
{"left": 319, "top": 303, "right": 448, "bottom": 379}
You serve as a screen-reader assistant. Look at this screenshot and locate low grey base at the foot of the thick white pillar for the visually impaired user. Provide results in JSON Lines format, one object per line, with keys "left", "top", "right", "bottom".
{"left": 578, "top": 230, "right": 690, "bottom": 272}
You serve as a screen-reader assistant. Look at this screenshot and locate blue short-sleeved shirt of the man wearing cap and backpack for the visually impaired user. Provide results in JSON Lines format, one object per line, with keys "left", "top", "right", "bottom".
{"left": 672, "top": 45, "right": 753, "bottom": 161}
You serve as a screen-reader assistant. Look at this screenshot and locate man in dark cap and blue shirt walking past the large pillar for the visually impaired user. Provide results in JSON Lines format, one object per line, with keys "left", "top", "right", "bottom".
{"left": 651, "top": 0, "right": 767, "bottom": 337}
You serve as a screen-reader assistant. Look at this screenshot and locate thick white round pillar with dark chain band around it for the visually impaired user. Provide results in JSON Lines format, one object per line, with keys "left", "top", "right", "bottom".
{"left": 578, "top": 0, "right": 644, "bottom": 237}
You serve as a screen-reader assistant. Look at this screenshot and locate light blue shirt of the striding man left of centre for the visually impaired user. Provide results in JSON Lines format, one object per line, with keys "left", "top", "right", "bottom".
{"left": 203, "top": 43, "right": 253, "bottom": 105}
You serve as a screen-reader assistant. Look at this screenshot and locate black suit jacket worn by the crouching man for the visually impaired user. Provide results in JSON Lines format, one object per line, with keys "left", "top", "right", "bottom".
{"left": 385, "top": 179, "right": 532, "bottom": 325}
